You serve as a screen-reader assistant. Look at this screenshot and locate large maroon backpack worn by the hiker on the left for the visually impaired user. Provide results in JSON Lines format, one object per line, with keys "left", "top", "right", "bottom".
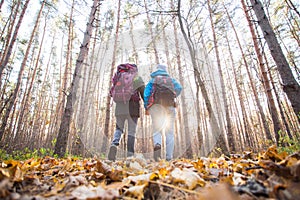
{"left": 110, "top": 63, "right": 139, "bottom": 103}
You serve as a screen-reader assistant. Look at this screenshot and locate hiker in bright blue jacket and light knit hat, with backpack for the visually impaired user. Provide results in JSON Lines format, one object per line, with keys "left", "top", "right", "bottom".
{"left": 144, "top": 64, "right": 182, "bottom": 161}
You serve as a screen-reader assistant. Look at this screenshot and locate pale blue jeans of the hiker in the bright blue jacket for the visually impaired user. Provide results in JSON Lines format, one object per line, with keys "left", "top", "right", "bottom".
{"left": 149, "top": 104, "right": 176, "bottom": 160}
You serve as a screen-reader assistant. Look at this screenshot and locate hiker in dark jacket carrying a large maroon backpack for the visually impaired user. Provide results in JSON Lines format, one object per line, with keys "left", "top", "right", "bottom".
{"left": 108, "top": 63, "right": 145, "bottom": 161}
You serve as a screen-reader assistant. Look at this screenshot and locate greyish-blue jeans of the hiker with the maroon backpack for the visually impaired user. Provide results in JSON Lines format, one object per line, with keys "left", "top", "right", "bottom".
{"left": 111, "top": 115, "right": 138, "bottom": 155}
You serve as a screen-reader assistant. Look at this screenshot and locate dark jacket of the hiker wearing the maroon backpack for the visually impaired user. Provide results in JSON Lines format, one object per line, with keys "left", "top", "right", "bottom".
{"left": 115, "top": 76, "right": 145, "bottom": 117}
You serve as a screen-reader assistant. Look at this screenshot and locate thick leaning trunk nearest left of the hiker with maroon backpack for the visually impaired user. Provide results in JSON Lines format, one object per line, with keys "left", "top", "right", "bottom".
{"left": 54, "top": 0, "right": 100, "bottom": 157}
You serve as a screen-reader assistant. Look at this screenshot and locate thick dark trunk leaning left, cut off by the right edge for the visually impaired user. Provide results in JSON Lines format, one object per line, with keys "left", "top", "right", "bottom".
{"left": 250, "top": 0, "right": 300, "bottom": 121}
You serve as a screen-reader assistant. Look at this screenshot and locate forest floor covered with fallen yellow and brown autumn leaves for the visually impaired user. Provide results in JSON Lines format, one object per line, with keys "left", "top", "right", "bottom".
{"left": 0, "top": 147, "right": 300, "bottom": 200}
